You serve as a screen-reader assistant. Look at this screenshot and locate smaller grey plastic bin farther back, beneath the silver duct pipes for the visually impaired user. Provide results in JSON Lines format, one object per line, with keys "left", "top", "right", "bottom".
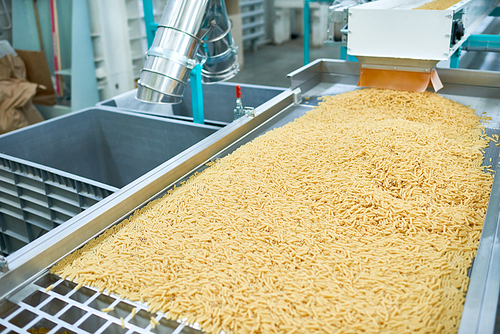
{"left": 98, "top": 82, "right": 285, "bottom": 126}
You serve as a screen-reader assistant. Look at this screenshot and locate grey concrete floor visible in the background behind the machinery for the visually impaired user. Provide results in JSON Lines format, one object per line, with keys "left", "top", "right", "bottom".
{"left": 230, "top": 18, "right": 500, "bottom": 87}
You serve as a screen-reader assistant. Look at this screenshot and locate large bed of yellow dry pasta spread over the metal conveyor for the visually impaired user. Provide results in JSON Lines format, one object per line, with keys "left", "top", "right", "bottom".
{"left": 52, "top": 89, "right": 493, "bottom": 334}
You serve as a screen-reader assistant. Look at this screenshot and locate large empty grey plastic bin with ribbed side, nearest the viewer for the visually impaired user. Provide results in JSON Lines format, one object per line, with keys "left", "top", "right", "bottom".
{"left": 0, "top": 108, "right": 220, "bottom": 254}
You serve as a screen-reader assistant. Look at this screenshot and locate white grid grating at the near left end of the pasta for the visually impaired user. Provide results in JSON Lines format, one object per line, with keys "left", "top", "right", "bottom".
{"left": 0, "top": 272, "right": 201, "bottom": 334}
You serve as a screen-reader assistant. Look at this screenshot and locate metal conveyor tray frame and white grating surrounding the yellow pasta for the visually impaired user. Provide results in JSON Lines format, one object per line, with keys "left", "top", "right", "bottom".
{"left": 0, "top": 60, "right": 500, "bottom": 333}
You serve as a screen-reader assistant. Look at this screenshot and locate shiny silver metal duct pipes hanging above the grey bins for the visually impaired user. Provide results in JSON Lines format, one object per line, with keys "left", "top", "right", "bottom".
{"left": 136, "top": 0, "right": 239, "bottom": 104}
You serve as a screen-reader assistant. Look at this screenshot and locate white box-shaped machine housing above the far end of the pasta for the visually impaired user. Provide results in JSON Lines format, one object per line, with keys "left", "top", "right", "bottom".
{"left": 347, "top": 0, "right": 500, "bottom": 68}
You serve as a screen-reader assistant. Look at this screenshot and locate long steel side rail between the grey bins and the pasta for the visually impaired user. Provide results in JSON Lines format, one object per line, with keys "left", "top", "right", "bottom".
{"left": 0, "top": 89, "right": 295, "bottom": 299}
